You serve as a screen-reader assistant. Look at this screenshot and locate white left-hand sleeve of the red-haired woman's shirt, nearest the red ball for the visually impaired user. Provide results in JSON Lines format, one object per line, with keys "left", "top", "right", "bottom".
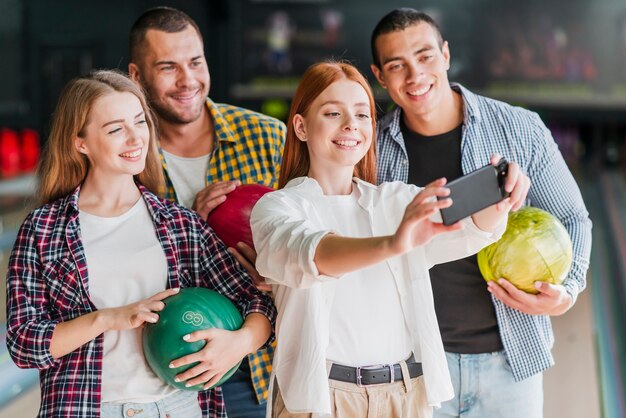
{"left": 250, "top": 192, "right": 335, "bottom": 289}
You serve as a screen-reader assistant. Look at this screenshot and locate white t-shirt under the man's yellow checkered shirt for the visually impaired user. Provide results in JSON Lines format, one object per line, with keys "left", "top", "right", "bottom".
{"left": 163, "top": 150, "right": 211, "bottom": 208}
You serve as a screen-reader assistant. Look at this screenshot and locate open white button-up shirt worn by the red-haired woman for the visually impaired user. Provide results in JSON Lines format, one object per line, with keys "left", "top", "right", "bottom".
{"left": 250, "top": 177, "right": 506, "bottom": 417}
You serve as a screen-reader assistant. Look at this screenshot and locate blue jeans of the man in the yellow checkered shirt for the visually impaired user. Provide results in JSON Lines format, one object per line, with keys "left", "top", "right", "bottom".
{"left": 222, "top": 357, "right": 266, "bottom": 418}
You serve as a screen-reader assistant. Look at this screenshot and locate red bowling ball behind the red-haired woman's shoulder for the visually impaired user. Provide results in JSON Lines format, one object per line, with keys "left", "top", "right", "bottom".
{"left": 207, "top": 184, "right": 274, "bottom": 248}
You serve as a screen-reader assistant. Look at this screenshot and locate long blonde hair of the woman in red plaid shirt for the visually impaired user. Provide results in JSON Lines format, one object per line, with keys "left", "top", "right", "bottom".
{"left": 37, "top": 70, "right": 165, "bottom": 204}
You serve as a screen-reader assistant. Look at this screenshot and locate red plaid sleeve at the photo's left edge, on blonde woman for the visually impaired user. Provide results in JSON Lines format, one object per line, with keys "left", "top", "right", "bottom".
{"left": 6, "top": 218, "right": 60, "bottom": 370}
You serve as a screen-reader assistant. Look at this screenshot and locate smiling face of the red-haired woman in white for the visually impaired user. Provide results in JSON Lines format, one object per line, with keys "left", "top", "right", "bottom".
{"left": 293, "top": 79, "right": 374, "bottom": 178}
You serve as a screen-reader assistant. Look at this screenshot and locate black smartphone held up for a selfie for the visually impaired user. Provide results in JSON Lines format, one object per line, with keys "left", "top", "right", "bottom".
{"left": 438, "top": 158, "right": 509, "bottom": 225}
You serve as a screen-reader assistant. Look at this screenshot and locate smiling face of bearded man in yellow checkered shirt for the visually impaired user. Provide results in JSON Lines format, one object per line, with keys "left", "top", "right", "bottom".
{"left": 129, "top": 26, "right": 211, "bottom": 124}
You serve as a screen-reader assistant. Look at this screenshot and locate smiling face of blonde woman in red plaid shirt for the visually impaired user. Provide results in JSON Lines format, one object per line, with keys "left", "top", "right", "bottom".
{"left": 74, "top": 92, "right": 150, "bottom": 177}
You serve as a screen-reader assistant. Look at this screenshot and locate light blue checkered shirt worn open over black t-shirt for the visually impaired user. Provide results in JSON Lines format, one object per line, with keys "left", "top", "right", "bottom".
{"left": 378, "top": 84, "right": 591, "bottom": 380}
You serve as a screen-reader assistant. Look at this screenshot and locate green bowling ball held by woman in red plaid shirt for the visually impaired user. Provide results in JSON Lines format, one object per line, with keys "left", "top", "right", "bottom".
{"left": 143, "top": 287, "right": 243, "bottom": 391}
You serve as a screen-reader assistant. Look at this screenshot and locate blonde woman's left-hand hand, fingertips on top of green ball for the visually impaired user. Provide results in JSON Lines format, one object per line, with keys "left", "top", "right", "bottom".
{"left": 99, "top": 288, "right": 180, "bottom": 331}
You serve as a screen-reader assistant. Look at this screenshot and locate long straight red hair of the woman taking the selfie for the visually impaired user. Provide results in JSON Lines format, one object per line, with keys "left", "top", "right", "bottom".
{"left": 278, "top": 62, "right": 376, "bottom": 189}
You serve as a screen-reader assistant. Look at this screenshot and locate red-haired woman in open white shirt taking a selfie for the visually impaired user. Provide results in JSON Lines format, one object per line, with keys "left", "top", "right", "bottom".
{"left": 251, "top": 63, "right": 528, "bottom": 418}
